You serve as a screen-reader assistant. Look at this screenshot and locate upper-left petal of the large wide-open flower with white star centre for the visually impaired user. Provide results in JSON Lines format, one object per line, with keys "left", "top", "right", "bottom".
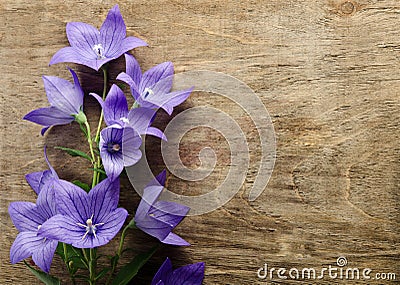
{"left": 54, "top": 180, "right": 90, "bottom": 223}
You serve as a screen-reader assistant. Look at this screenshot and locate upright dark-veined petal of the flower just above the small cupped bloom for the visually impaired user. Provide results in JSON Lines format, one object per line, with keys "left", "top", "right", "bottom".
{"left": 103, "top": 84, "right": 128, "bottom": 126}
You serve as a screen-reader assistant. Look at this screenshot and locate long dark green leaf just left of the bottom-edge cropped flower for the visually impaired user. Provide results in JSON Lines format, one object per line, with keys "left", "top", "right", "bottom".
{"left": 112, "top": 245, "right": 158, "bottom": 285}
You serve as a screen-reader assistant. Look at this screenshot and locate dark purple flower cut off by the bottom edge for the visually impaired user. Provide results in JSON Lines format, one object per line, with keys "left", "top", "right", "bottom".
{"left": 151, "top": 257, "right": 204, "bottom": 285}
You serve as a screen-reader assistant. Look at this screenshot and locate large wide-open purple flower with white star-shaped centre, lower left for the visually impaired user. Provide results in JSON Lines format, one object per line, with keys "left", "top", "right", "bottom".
{"left": 38, "top": 176, "right": 128, "bottom": 248}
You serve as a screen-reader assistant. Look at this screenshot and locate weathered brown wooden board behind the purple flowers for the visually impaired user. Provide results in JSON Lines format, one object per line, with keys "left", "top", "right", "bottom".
{"left": 0, "top": 0, "right": 400, "bottom": 284}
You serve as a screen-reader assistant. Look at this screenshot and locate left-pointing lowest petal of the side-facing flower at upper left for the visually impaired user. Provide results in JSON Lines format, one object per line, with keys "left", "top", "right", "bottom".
{"left": 24, "top": 107, "right": 74, "bottom": 127}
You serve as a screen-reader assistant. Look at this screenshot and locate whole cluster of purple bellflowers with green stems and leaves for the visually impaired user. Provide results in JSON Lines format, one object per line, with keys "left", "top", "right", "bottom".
{"left": 9, "top": 5, "right": 204, "bottom": 285}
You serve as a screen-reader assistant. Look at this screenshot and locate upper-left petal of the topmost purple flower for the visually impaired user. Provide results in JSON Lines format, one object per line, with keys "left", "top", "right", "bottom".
{"left": 66, "top": 22, "right": 100, "bottom": 60}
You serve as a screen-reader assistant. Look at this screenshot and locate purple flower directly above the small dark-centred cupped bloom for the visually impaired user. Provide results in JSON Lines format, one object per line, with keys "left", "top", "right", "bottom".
{"left": 90, "top": 84, "right": 166, "bottom": 140}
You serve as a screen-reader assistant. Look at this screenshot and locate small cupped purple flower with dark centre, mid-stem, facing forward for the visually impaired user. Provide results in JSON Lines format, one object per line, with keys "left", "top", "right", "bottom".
{"left": 99, "top": 127, "right": 142, "bottom": 180}
